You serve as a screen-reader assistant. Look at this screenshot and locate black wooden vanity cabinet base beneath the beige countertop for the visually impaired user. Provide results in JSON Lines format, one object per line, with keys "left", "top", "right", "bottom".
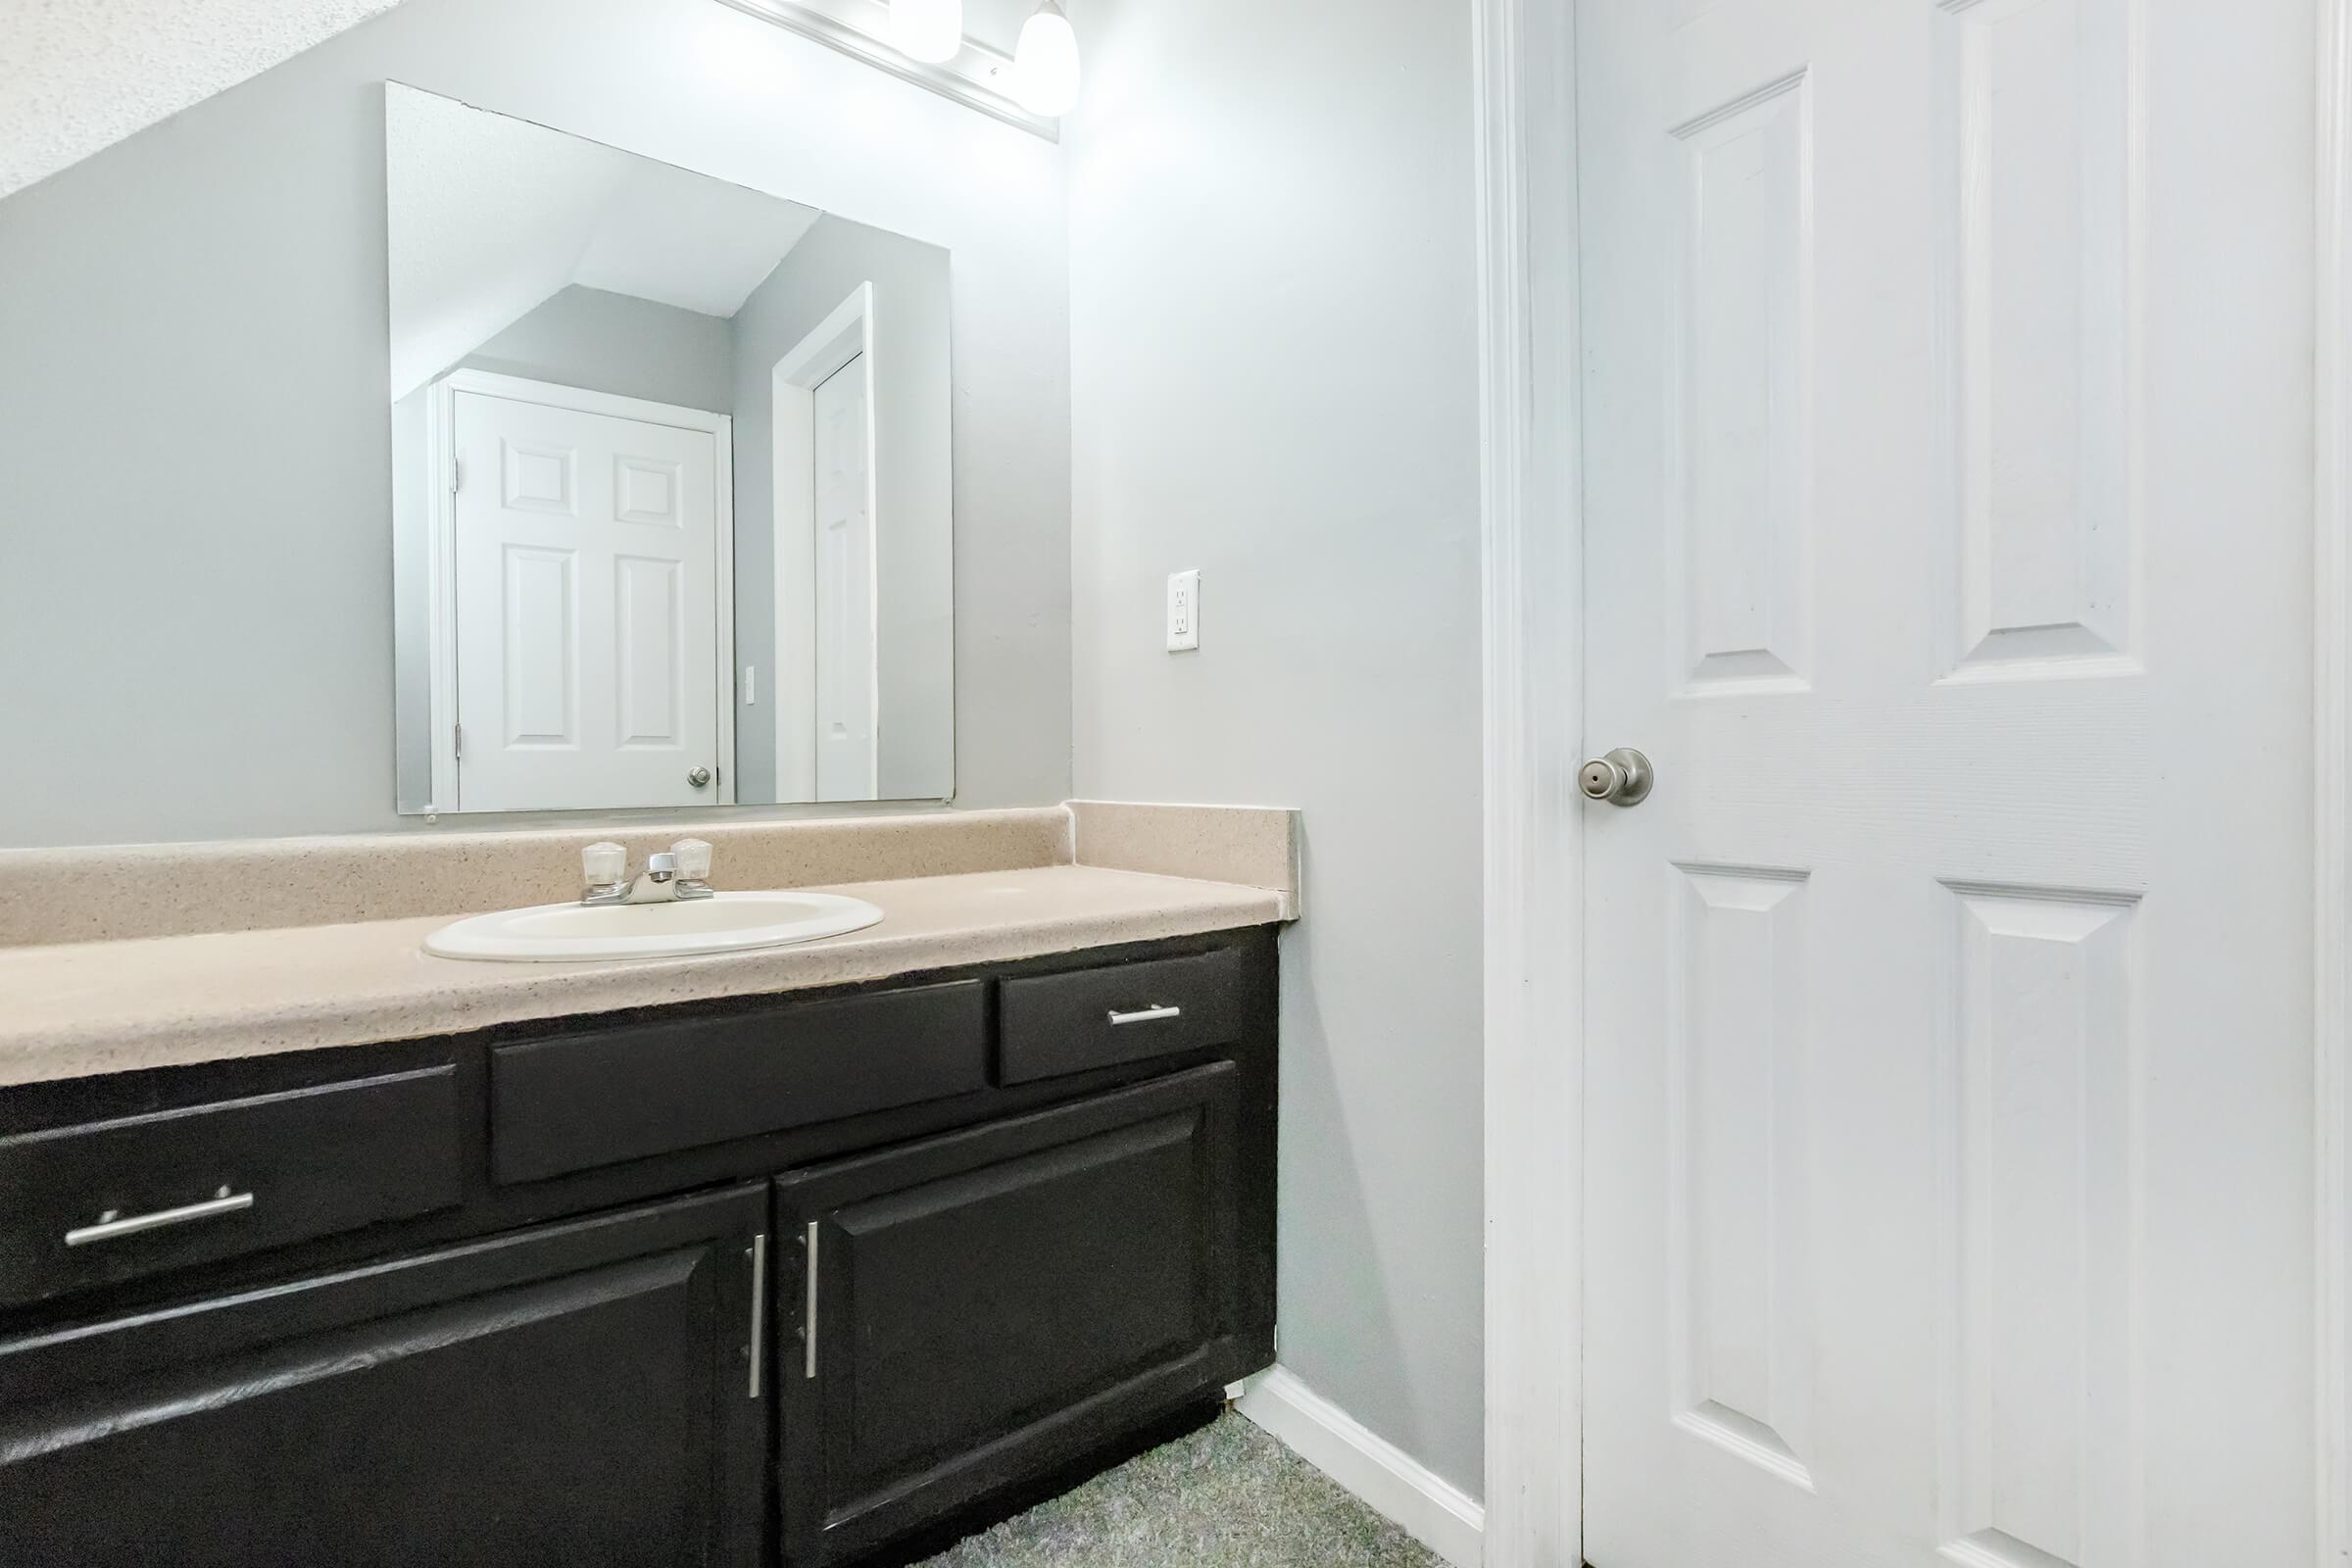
{"left": 0, "top": 911, "right": 1275, "bottom": 1568}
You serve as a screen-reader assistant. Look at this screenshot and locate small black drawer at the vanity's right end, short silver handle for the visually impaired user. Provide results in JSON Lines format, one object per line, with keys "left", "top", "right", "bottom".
{"left": 998, "top": 948, "right": 1249, "bottom": 1084}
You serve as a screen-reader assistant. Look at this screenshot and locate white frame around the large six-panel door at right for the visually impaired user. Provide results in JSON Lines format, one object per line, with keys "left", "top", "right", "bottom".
{"left": 1472, "top": 0, "right": 2352, "bottom": 1568}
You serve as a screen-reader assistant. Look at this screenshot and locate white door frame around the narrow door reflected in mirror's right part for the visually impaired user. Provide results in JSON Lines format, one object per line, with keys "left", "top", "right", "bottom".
{"left": 769, "top": 282, "right": 882, "bottom": 800}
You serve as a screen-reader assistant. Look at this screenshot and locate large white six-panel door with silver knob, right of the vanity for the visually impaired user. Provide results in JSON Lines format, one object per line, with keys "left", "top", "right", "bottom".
{"left": 1576, "top": 0, "right": 2317, "bottom": 1568}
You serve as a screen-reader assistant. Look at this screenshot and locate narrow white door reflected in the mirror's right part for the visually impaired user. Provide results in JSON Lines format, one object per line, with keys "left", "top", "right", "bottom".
{"left": 813, "top": 355, "right": 880, "bottom": 800}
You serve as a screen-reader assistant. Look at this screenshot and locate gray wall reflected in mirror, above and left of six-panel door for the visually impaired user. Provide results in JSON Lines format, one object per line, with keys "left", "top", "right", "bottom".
{"left": 393, "top": 284, "right": 733, "bottom": 808}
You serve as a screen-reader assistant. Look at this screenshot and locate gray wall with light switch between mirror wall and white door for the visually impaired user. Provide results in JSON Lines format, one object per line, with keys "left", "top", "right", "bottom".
{"left": 1068, "top": 0, "right": 1482, "bottom": 1493}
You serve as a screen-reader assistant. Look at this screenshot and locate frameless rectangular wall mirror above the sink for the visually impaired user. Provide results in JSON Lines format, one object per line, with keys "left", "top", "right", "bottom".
{"left": 383, "top": 82, "right": 955, "bottom": 813}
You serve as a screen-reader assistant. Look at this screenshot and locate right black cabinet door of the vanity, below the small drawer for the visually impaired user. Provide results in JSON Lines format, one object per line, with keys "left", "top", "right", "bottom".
{"left": 776, "top": 1062, "right": 1249, "bottom": 1568}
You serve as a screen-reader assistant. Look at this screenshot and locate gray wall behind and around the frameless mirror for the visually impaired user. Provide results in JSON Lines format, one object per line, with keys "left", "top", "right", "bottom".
{"left": 0, "top": 0, "right": 1070, "bottom": 844}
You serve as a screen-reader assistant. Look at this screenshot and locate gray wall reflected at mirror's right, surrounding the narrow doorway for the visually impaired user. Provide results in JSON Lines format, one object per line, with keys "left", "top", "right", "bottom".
{"left": 734, "top": 214, "right": 955, "bottom": 800}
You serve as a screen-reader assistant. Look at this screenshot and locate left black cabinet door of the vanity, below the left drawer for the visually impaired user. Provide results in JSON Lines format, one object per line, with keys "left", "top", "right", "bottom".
{"left": 0, "top": 1187, "right": 766, "bottom": 1568}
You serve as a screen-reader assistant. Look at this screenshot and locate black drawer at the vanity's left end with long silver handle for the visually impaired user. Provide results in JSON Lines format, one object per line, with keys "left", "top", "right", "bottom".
{"left": 0, "top": 1065, "right": 464, "bottom": 1302}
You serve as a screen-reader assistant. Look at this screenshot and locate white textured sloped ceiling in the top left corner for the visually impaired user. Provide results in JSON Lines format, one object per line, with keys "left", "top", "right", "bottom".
{"left": 0, "top": 0, "right": 398, "bottom": 195}
